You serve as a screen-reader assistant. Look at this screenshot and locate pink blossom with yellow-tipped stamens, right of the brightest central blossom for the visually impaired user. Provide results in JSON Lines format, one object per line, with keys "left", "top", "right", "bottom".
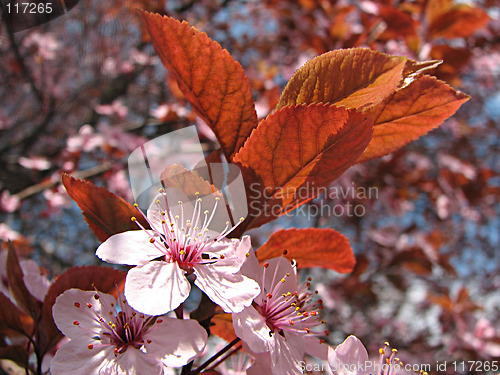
{"left": 233, "top": 257, "right": 328, "bottom": 375}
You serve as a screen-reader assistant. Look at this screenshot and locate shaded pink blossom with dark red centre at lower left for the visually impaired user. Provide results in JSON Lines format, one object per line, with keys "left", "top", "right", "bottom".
{"left": 51, "top": 289, "right": 207, "bottom": 375}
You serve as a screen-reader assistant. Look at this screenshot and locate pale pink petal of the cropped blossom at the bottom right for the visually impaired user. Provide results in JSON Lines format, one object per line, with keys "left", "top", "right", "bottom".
{"left": 328, "top": 336, "right": 368, "bottom": 375}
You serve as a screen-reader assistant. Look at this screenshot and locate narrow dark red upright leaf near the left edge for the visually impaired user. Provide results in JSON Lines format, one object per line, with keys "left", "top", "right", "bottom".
{"left": 6, "top": 243, "right": 41, "bottom": 321}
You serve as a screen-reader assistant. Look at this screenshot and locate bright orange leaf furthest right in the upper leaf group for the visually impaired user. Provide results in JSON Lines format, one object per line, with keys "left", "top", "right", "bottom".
{"left": 358, "top": 75, "right": 469, "bottom": 162}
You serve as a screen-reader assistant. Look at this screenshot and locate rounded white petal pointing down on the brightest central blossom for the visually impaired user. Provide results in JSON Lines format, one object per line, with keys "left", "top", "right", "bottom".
{"left": 125, "top": 261, "right": 191, "bottom": 315}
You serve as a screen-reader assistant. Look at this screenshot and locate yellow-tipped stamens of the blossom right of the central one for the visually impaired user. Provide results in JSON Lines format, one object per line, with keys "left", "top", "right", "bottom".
{"left": 255, "top": 257, "right": 328, "bottom": 336}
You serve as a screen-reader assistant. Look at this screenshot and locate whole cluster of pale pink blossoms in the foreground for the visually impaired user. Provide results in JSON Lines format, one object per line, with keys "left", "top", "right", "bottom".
{"left": 41, "top": 189, "right": 420, "bottom": 375}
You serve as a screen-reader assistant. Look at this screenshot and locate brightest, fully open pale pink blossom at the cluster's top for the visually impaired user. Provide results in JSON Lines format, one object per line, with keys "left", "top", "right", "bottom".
{"left": 96, "top": 191, "right": 260, "bottom": 315}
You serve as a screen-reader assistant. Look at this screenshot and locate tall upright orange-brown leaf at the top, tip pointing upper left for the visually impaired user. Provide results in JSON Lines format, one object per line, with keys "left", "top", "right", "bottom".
{"left": 141, "top": 12, "right": 257, "bottom": 159}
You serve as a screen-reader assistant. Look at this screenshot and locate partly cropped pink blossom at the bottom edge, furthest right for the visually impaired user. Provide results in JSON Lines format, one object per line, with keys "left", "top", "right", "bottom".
{"left": 328, "top": 336, "right": 415, "bottom": 375}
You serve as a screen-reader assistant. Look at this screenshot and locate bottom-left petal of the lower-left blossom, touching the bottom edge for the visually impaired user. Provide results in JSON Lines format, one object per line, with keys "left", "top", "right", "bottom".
{"left": 50, "top": 339, "right": 114, "bottom": 375}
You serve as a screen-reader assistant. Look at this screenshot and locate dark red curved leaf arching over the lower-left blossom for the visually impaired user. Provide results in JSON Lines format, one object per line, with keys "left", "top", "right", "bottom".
{"left": 40, "top": 266, "right": 126, "bottom": 351}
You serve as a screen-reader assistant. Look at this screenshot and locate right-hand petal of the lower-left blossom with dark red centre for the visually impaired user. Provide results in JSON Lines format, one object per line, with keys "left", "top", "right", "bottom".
{"left": 144, "top": 318, "right": 207, "bottom": 367}
